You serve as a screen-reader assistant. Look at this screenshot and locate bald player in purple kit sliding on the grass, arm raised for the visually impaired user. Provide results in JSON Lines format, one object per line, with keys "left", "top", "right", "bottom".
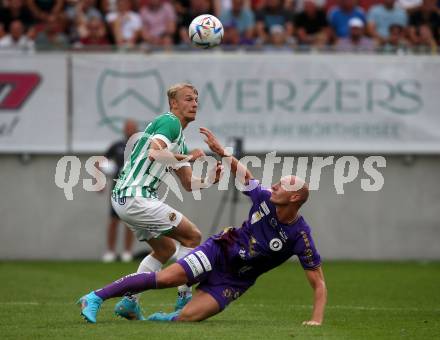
{"left": 80, "top": 128, "right": 327, "bottom": 326}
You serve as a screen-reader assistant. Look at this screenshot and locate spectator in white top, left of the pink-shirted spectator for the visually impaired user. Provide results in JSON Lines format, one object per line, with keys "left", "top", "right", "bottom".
{"left": 106, "top": 0, "right": 142, "bottom": 47}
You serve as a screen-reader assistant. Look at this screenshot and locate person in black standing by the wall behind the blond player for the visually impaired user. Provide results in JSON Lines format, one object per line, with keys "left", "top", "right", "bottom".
{"left": 102, "top": 120, "right": 138, "bottom": 262}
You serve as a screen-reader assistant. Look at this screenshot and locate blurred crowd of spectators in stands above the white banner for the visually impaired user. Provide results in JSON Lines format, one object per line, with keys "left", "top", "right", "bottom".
{"left": 0, "top": 0, "right": 440, "bottom": 53}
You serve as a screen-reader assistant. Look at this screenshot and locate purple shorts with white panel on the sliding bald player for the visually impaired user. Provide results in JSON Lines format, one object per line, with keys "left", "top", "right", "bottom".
{"left": 177, "top": 238, "right": 255, "bottom": 310}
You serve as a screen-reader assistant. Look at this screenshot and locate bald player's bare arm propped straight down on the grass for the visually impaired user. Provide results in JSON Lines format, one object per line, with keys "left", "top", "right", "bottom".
{"left": 303, "top": 267, "right": 327, "bottom": 326}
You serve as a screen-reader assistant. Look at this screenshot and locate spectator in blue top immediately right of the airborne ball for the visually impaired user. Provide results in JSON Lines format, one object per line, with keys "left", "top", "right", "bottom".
{"left": 220, "top": 0, "right": 255, "bottom": 45}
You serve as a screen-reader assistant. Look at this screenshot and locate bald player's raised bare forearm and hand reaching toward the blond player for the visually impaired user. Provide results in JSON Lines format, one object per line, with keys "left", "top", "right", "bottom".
{"left": 200, "top": 127, "right": 254, "bottom": 185}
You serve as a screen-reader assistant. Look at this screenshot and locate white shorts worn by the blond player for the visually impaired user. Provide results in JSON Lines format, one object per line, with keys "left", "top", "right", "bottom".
{"left": 112, "top": 197, "right": 183, "bottom": 241}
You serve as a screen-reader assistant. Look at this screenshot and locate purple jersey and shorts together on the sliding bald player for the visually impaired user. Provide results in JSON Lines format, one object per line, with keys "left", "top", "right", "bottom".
{"left": 177, "top": 180, "right": 321, "bottom": 309}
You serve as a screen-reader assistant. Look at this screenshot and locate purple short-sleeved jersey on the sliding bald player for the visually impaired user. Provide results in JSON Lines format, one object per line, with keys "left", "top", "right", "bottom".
{"left": 213, "top": 180, "right": 321, "bottom": 279}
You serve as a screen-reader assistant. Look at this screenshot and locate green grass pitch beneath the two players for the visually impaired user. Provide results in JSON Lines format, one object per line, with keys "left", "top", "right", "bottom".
{"left": 0, "top": 262, "right": 440, "bottom": 340}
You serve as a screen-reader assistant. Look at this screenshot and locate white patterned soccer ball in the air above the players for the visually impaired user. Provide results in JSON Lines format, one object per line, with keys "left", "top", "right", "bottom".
{"left": 188, "top": 14, "right": 224, "bottom": 49}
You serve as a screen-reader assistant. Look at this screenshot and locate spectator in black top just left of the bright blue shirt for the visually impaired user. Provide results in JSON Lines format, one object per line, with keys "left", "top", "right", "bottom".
{"left": 295, "top": 0, "right": 329, "bottom": 47}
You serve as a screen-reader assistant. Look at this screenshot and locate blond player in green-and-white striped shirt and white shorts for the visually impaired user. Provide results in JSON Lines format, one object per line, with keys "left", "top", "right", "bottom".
{"left": 112, "top": 84, "right": 221, "bottom": 320}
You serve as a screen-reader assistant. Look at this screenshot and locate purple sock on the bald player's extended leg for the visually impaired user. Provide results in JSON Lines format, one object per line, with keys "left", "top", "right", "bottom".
{"left": 95, "top": 272, "right": 156, "bottom": 300}
